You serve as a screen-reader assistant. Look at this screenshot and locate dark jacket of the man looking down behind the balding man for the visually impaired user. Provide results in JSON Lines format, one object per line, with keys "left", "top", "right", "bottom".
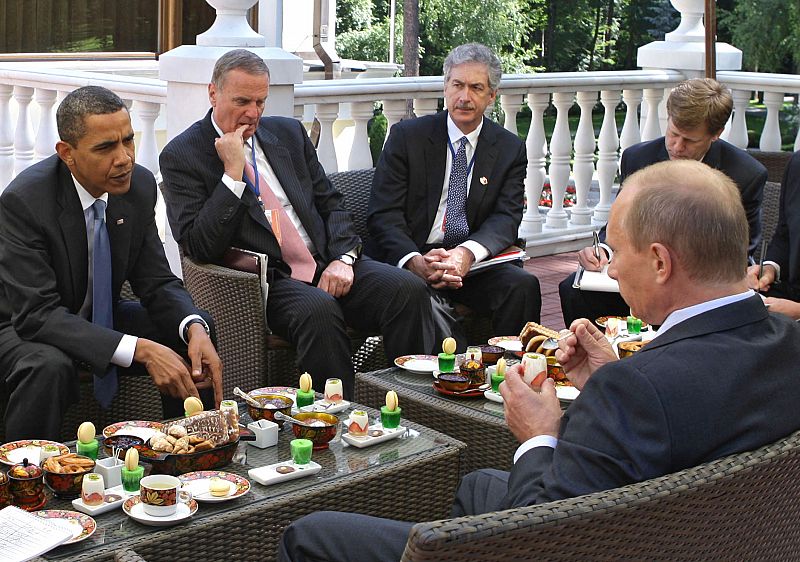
{"left": 620, "top": 137, "right": 767, "bottom": 255}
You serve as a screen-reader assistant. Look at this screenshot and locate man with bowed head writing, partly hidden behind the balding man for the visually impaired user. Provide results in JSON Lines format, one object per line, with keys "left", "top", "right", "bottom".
{"left": 558, "top": 78, "right": 767, "bottom": 326}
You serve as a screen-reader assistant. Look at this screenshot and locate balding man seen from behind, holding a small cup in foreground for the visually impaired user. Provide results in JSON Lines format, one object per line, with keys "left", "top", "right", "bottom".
{"left": 279, "top": 160, "right": 800, "bottom": 561}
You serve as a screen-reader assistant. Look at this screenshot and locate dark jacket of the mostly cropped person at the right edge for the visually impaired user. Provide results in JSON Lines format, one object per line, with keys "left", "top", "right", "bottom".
{"left": 766, "top": 152, "right": 800, "bottom": 300}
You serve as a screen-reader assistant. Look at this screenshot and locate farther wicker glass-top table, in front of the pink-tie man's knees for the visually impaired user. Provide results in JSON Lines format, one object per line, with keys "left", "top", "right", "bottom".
{"left": 356, "top": 367, "right": 568, "bottom": 473}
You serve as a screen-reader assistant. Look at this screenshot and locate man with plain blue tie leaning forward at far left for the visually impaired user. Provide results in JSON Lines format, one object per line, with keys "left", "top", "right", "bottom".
{"left": 0, "top": 86, "right": 222, "bottom": 440}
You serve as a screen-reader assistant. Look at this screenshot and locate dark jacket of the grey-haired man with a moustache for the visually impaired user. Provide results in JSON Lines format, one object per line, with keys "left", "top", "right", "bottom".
{"left": 365, "top": 111, "right": 528, "bottom": 265}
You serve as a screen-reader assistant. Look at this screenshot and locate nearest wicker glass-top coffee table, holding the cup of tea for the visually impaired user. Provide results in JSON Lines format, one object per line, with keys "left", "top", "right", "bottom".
{"left": 34, "top": 403, "right": 465, "bottom": 562}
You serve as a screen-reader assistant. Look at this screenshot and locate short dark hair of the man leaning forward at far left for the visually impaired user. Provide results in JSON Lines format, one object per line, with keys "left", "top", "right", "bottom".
{"left": 56, "top": 86, "right": 128, "bottom": 146}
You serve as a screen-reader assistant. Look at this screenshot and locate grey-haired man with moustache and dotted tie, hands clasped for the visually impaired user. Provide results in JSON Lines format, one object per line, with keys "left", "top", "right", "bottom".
{"left": 365, "top": 43, "right": 541, "bottom": 347}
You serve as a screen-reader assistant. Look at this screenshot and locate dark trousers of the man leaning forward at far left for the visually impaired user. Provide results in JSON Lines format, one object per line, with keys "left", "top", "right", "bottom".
{"left": 0, "top": 301, "right": 214, "bottom": 441}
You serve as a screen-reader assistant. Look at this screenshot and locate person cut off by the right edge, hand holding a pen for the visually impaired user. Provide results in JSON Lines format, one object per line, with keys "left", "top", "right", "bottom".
{"left": 747, "top": 152, "right": 800, "bottom": 320}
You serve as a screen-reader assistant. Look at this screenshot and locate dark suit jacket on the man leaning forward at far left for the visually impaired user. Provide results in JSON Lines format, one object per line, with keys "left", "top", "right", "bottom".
{"left": 0, "top": 155, "right": 198, "bottom": 372}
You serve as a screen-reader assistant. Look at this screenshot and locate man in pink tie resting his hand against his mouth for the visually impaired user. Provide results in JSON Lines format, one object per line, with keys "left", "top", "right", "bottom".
{"left": 160, "top": 49, "right": 433, "bottom": 399}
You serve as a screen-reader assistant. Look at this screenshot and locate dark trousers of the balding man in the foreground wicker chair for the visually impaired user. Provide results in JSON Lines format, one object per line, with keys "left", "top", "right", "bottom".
{"left": 278, "top": 464, "right": 508, "bottom": 562}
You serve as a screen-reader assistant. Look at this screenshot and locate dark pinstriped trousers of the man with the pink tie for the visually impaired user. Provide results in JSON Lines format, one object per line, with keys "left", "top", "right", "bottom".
{"left": 267, "top": 257, "right": 434, "bottom": 399}
